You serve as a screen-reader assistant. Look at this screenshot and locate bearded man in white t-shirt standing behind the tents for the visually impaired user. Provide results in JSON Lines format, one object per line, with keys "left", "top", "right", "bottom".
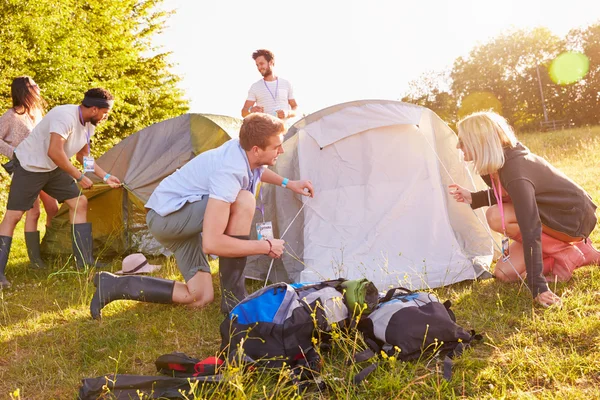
{"left": 242, "top": 49, "right": 298, "bottom": 121}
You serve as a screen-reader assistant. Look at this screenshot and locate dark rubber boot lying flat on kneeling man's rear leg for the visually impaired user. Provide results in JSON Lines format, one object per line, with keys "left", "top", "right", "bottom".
{"left": 90, "top": 271, "right": 175, "bottom": 319}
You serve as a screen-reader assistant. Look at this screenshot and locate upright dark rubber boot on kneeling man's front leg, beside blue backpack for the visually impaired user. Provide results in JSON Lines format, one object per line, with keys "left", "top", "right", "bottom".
{"left": 219, "top": 235, "right": 250, "bottom": 314}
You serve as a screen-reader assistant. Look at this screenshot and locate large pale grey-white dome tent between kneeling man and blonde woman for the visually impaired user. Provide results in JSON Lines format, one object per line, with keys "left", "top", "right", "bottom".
{"left": 246, "top": 100, "right": 494, "bottom": 290}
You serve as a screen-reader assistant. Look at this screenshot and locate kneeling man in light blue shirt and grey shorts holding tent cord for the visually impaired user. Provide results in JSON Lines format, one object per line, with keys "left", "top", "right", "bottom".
{"left": 90, "top": 113, "right": 313, "bottom": 319}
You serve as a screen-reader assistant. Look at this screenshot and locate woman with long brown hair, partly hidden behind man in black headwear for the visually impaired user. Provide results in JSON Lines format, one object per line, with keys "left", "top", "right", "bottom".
{"left": 0, "top": 76, "right": 58, "bottom": 274}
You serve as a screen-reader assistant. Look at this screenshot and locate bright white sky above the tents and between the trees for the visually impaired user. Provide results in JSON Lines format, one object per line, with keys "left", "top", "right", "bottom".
{"left": 156, "top": 0, "right": 600, "bottom": 117}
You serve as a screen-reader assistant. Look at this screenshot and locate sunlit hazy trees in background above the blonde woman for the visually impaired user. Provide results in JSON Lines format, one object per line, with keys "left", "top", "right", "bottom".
{"left": 402, "top": 23, "right": 600, "bottom": 131}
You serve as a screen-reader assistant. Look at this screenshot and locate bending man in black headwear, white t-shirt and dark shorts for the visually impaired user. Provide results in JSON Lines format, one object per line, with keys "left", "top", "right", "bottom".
{"left": 0, "top": 88, "right": 121, "bottom": 288}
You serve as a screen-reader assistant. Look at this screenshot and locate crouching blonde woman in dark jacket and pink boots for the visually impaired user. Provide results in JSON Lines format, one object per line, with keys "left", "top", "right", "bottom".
{"left": 450, "top": 112, "right": 600, "bottom": 306}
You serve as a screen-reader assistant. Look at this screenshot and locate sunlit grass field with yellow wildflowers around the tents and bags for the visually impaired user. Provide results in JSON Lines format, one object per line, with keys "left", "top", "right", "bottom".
{"left": 0, "top": 127, "right": 600, "bottom": 399}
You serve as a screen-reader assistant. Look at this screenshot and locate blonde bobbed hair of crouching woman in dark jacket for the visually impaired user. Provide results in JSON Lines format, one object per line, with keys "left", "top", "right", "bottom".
{"left": 457, "top": 111, "right": 517, "bottom": 175}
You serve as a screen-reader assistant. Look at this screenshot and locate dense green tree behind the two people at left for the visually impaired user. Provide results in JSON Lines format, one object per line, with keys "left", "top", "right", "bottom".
{"left": 0, "top": 0, "right": 188, "bottom": 156}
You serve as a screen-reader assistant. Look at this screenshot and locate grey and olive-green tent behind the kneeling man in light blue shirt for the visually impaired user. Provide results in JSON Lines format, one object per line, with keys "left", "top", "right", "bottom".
{"left": 42, "top": 114, "right": 242, "bottom": 257}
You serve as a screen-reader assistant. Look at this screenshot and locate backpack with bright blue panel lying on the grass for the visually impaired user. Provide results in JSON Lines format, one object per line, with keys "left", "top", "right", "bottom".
{"left": 220, "top": 280, "right": 348, "bottom": 381}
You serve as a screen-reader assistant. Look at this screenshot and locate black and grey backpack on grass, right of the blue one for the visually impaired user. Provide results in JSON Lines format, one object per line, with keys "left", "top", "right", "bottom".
{"left": 354, "top": 288, "right": 482, "bottom": 383}
